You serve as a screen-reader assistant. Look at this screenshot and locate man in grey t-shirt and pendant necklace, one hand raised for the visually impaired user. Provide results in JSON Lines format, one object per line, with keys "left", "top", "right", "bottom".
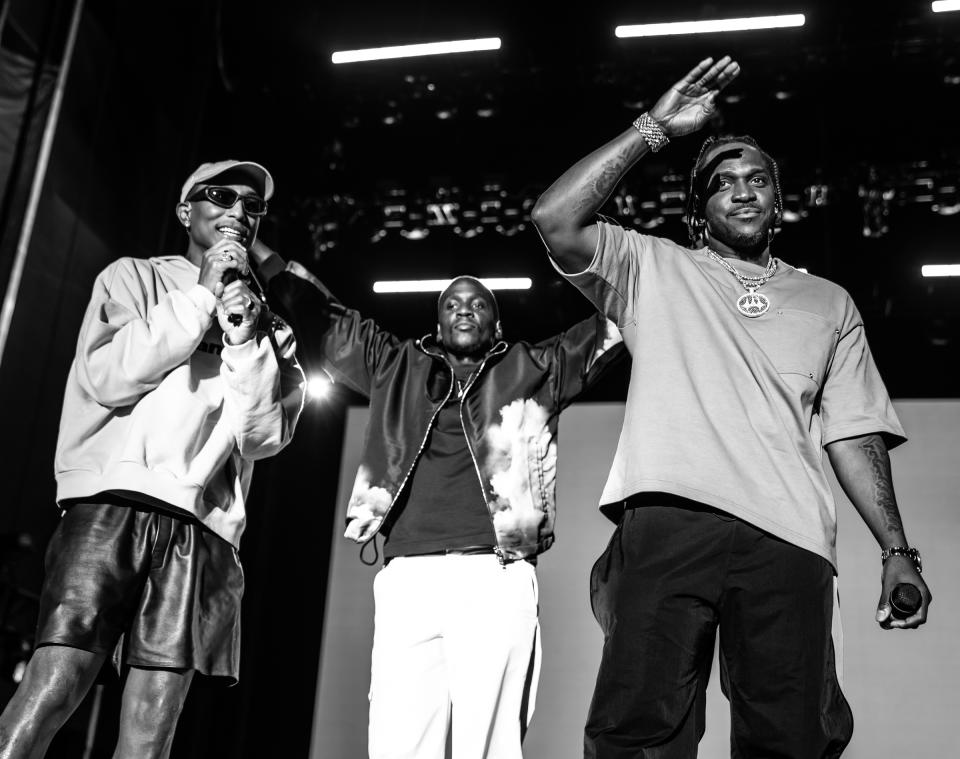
{"left": 533, "top": 57, "right": 931, "bottom": 759}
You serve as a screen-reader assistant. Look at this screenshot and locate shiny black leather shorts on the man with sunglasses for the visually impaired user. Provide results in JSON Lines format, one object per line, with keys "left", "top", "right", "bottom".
{"left": 36, "top": 497, "right": 243, "bottom": 685}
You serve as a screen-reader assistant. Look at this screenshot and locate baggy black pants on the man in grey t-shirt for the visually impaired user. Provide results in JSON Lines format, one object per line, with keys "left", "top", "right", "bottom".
{"left": 584, "top": 496, "right": 853, "bottom": 759}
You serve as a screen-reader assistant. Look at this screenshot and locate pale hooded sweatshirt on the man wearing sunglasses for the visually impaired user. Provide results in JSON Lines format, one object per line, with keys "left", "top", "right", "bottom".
{"left": 55, "top": 256, "right": 304, "bottom": 546}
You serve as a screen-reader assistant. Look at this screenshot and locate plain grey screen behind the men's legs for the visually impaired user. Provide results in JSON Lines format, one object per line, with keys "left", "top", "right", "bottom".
{"left": 310, "top": 401, "right": 960, "bottom": 759}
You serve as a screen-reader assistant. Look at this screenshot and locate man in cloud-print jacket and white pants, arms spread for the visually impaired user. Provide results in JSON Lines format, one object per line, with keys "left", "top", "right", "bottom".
{"left": 251, "top": 243, "right": 621, "bottom": 759}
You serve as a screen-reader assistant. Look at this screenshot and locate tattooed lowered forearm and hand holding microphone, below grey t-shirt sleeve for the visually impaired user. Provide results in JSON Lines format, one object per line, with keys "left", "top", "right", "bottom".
{"left": 827, "top": 434, "right": 932, "bottom": 629}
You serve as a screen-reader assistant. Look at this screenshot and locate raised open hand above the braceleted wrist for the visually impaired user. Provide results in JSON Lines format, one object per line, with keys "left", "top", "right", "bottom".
{"left": 650, "top": 55, "right": 740, "bottom": 137}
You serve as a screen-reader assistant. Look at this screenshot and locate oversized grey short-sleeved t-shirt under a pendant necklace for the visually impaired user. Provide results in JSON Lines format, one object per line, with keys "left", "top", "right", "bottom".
{"left": 561, "top": 222, "right": 906, "bottom": 567}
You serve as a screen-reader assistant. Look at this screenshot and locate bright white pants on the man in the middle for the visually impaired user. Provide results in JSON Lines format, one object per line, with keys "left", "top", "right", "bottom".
{"left": 369, "top": 554, "right": 540, "bottom": 759}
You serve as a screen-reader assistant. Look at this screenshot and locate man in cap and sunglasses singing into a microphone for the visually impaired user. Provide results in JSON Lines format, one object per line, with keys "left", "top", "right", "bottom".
{"left": 0, "top": 161, "right": 303, "bottom": 759}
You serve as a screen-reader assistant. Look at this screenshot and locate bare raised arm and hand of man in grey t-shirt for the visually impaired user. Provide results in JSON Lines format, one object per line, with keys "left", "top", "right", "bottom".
{"left": 533, "top": 56, "right": 740, "bottom": 272}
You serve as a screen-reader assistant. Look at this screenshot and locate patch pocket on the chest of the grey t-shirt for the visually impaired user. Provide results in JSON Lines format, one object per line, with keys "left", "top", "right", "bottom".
{"left": 758, "top": 308, "right": 839, "bottom": 388}
